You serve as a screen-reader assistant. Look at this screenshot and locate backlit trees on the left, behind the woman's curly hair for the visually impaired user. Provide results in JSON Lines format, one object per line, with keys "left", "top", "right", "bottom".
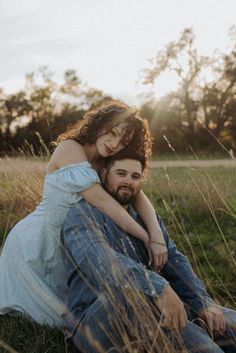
{"left": 0, "top": 66, "right": 110, "bottom": 153}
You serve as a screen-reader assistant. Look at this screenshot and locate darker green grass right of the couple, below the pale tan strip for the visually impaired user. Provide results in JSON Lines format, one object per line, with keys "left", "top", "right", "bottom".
{"left": 155, "top": 208, "right": 236, "bottom": 309}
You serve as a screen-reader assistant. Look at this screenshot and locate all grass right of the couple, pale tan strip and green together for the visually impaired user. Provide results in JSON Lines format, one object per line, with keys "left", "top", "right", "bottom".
{"left": 145, "top": 167, "right": 236, "bottom": 308}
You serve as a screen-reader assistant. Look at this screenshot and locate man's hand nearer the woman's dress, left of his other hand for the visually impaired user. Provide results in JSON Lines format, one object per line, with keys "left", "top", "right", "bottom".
{"left": 156, "top": 285, "right": 188, "bottom": 330}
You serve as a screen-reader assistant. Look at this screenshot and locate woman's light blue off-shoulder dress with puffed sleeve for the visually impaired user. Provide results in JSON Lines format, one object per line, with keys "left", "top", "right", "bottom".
{"left": 0, "top": 161, "right": 100, "bottom": 327}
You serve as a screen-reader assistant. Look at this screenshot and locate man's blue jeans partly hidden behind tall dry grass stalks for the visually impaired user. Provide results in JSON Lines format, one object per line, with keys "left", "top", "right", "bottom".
{"left": 66, "top": 294, "right": 236, "bottom": 353}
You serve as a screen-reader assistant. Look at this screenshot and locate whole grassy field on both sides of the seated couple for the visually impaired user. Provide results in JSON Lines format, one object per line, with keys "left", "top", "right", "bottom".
{"left": 0, "top": 160, "right": 236, "bottom": 353}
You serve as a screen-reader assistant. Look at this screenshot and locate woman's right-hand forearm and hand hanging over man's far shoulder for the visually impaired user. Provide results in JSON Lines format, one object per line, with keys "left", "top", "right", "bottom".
{"left": 135, "top": 191, "right": 168, "bottom": 271}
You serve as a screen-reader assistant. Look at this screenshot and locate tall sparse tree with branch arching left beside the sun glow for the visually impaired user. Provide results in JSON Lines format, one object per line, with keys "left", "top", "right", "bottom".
{"left": 144, "top": 28, "right": 209, "bottom": 141}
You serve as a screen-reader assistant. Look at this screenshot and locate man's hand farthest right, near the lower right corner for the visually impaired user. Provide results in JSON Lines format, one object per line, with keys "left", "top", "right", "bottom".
{"left": 198, "top": 306, "right": 226, "bottom": 337}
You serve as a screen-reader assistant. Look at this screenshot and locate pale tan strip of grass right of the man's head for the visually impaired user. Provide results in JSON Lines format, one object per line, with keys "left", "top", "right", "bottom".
{"left": 145, "top": 167, "right": 236, "bottom": 216}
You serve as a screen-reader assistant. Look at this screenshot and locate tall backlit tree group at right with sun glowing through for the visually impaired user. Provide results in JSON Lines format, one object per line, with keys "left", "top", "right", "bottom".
{"left": 144, "top": 29, "right": 236, "bottom": 152}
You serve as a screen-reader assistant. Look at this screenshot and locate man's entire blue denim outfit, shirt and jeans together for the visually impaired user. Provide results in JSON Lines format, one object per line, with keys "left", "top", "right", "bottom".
{"left": 63, "top": 203, "right": 236, "bottom": 353}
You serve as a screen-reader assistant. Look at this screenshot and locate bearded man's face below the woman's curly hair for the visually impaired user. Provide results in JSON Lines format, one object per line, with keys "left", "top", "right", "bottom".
{"left": 101, "top": 159, "right": 142, "bottom": 206}
